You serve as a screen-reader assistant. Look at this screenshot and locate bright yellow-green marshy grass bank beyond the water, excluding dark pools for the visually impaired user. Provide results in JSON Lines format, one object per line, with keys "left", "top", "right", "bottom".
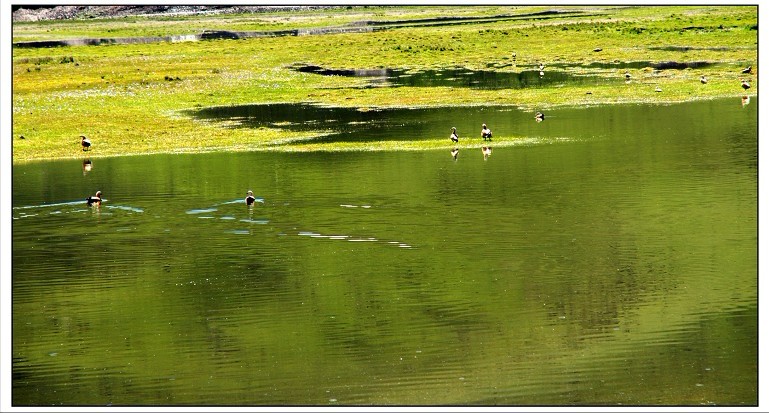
{"left": 12, "top": 5, "right": 758, "bottom": 163}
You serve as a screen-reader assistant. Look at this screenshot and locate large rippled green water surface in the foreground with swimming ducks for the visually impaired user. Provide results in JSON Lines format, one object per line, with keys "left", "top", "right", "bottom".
{"left": 12, "top": 97, "right": 758, "bottom": 406}
